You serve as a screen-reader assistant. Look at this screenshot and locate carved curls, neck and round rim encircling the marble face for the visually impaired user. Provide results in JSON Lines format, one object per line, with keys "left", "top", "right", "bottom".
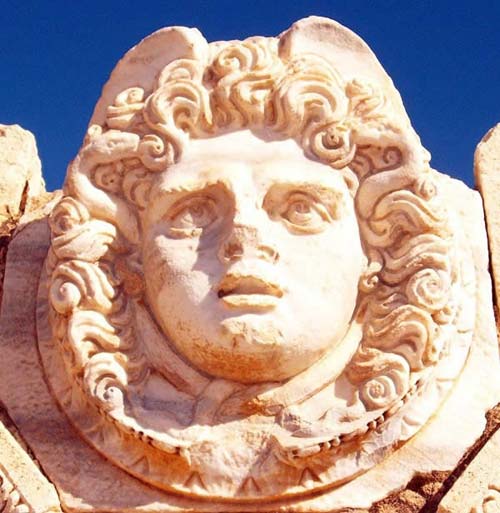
{"left": 38, "top": 22, "right": 474, "bottom": 502}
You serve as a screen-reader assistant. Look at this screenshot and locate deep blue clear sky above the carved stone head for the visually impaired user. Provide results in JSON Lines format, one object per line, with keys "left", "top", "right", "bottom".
{"left": 0, "top": 0, "right": 500, "bottom": 190}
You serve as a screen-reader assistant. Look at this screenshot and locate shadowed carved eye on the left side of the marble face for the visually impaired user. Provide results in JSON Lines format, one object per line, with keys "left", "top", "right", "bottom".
{"left": 168, "top": 197, "right": 217, "bottom": 235}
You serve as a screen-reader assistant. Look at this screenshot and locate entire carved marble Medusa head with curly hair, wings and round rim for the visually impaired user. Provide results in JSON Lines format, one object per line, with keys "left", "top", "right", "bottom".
{"left": 40, "top": 20, "right": 475, "bottom": 503}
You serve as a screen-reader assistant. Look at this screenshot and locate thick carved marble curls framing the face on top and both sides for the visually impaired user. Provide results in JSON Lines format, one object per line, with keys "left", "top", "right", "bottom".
{"left": 48, "top": 38, "right": 456, "bottom": 429}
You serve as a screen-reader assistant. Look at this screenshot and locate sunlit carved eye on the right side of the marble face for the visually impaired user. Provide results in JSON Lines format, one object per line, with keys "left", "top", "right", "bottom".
{"left": 281, "top": 193, "right": 331, "bottom": 233}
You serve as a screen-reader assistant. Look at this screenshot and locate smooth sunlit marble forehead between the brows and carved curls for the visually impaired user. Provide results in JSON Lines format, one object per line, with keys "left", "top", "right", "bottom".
{"left": 158, "top": 130, "right": 346, "bottom": 190}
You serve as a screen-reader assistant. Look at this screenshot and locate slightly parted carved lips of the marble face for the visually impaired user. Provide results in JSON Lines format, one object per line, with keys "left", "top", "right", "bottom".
{"left": 217, "top": 274, "right": 283, "bottom": 309}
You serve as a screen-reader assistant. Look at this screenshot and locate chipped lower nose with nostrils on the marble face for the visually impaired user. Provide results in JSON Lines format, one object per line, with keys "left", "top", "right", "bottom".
{"left": 219, "top": 225, "right": 279, "bottom": 263}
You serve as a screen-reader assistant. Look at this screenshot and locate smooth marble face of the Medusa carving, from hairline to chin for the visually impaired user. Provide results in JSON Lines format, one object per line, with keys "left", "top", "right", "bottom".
{"left": 143, "top": 131, "right": 365, "bottom": 382}
